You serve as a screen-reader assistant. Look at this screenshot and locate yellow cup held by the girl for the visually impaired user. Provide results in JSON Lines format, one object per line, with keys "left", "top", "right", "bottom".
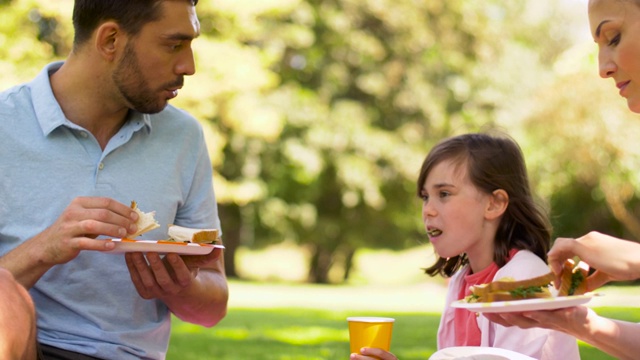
{"left": 347, "top": 316, "right": 395, "bottom": 354}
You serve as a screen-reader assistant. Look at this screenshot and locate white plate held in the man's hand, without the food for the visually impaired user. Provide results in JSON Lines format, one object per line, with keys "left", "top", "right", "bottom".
{"left": 105, "top": 239, "right": 224, "bottom": 255}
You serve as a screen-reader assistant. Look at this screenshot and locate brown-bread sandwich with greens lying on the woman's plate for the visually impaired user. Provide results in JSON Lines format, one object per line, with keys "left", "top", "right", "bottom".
{"left": 466, "top": 272, "right": 555, "bottom": 302}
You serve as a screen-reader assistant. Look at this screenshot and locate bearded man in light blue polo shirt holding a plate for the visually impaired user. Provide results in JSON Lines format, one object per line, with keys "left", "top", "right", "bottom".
{"left": 0, "top": 0, "right": 228, "bottom": 359}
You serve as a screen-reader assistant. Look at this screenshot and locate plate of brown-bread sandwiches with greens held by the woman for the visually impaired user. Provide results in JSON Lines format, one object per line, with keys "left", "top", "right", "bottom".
{"left": 451, "top": 260, "right": 598, "bottom": 313}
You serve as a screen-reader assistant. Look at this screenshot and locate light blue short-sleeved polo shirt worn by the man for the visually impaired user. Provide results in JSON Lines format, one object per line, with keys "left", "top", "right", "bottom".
{"left": 0, "top": 63, "right": 220, "bottom": 359}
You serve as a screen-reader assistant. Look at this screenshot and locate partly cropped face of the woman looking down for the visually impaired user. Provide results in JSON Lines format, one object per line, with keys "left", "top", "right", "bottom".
{"left": 589, "top": 0, "right": 640, "bottom": 113}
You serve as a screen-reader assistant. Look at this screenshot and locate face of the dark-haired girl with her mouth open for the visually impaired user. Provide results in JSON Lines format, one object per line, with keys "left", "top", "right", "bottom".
{"left": 421, "top": 160, "right": 497, "bottom": 271}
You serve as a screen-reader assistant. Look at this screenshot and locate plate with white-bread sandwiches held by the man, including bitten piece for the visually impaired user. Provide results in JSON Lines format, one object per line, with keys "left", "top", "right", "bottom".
{"left": 106, "top": 201, "right": 224, "bottom": 255}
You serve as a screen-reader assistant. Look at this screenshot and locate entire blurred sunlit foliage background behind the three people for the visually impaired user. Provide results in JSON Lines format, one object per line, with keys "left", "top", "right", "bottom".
{"left": 0, "top": 0, "right": 640, "bottom": 284}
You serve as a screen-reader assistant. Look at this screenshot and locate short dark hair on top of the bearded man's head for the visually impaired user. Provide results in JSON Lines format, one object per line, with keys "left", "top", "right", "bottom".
{"left": 73, "top": 0, "right": 198, "bottom": 48}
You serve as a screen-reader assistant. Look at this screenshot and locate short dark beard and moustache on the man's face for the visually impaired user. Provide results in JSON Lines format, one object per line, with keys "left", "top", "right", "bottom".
{"left": 112, "top": 42, "right": 183, "bottom": 114}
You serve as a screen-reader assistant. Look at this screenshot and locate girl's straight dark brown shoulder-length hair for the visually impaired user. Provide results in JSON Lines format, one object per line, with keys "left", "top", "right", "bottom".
{"left": 418, "top": 134, "right": 551, "bottom": 277}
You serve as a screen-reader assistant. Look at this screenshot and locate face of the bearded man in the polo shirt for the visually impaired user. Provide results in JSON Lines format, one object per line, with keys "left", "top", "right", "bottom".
{"left": 112, "top": 1, "right": 200, "bottom": 114}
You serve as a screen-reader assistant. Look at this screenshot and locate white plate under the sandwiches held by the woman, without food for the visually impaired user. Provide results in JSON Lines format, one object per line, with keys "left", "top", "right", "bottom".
{"left": 451, "top": 293, "right": 596, "bottom": 313}
